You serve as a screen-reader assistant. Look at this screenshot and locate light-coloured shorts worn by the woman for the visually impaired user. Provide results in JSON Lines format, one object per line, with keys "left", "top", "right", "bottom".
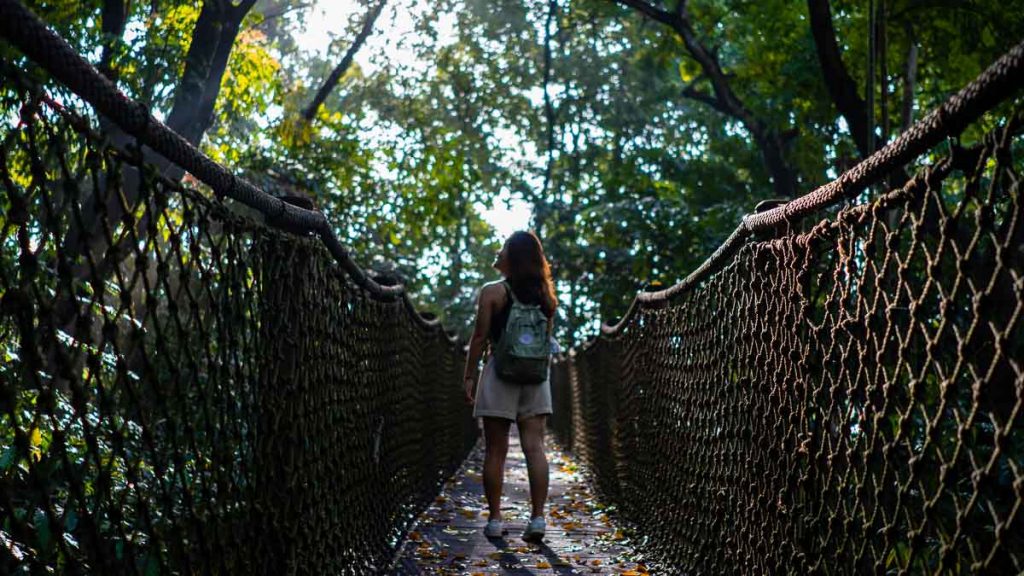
{"left": 473, "top": 358, "right": 551, "bottom": 420}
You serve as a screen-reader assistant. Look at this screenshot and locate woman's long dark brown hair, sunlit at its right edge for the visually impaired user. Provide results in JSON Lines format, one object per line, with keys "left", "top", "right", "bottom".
{"left": 505, "top": 231, "right": 558, "bottom": 318}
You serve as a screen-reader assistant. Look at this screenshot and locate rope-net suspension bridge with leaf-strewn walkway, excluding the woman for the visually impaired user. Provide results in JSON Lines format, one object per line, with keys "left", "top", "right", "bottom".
{"left": 0, "top": 0, "right": 1024, "bottom": 575}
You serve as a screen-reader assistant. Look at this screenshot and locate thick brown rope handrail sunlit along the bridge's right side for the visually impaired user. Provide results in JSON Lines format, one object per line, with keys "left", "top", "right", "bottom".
{"left": 601, "top": 41, "right": 1024, "bottom": 336}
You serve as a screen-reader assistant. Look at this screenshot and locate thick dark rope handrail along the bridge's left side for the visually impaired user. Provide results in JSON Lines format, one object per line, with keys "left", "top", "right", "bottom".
{"left": 0, "top": 0, "right": 452, "bottom": 329}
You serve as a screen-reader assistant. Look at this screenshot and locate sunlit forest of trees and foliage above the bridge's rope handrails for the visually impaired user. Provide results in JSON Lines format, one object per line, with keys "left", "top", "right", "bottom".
{"left": 8, "top": 0, "right": 1024, "bottom": 345}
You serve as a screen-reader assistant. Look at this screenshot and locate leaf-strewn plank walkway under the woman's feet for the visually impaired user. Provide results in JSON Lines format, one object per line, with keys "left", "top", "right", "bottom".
{"left": 391, "top": 425, "right": 654, "bottom": 576}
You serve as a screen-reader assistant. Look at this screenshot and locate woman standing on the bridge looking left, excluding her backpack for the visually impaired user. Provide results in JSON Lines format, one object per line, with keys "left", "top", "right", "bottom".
{"left": 465, "top": 227, "right": 558, "bottom": 541}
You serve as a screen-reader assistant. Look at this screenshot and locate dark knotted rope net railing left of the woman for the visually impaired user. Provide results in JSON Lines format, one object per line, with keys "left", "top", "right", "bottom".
{"left": 0, "top": 8, "right": 476, "bottom": 575}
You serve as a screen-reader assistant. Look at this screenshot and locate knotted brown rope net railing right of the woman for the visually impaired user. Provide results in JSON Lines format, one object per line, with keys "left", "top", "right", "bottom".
{"left": 553, "top": 46, "right": 1024, "bottom": 574}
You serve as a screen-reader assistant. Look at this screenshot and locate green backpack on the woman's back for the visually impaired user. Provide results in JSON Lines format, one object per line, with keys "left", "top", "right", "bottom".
{"left": 495, "top": 282, "right": 551, "bottom": 384}
